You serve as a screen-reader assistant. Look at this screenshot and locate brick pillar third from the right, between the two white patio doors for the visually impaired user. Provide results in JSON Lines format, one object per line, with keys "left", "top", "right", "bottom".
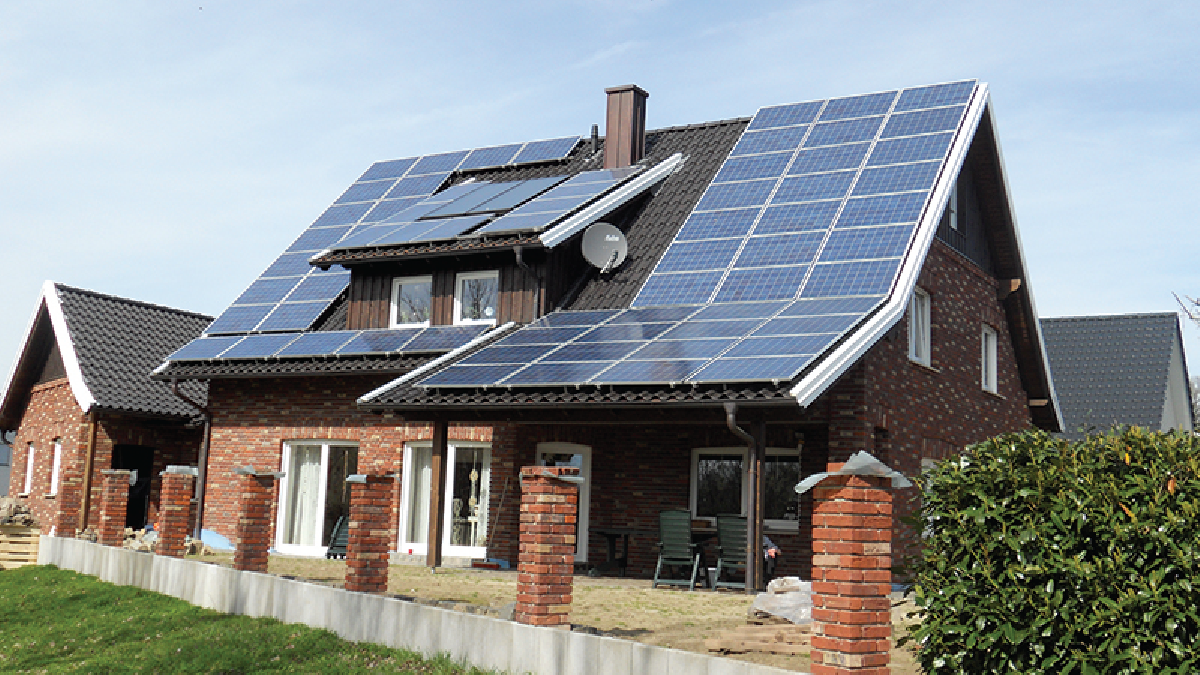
{"left": 346, "top": 474, "right": 396, "bottom": 593}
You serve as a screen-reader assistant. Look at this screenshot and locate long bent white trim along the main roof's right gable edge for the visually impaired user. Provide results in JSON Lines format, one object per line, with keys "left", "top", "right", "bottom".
{"left": 791, "top": 83, "right": 990, "bottom": 407}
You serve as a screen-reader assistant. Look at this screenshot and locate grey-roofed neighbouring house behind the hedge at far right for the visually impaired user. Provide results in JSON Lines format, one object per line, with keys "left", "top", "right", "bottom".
{"left": 1042, "top": 313, "right": 1195, "bottom": 440}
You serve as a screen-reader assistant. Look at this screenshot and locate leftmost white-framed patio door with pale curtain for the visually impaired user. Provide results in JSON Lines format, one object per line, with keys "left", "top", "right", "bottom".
{"left": 275, "top": 441, "right": 359, "bottom": 556}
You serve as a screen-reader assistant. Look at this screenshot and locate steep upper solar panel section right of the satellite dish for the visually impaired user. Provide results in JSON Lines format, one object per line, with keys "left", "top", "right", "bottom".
{"left": 632, "top": 80, "right": 976, "bottom": 306}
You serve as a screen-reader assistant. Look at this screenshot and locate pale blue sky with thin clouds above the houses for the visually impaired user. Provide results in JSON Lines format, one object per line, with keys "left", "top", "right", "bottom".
{"left": 0, "top": 0, "right": 1200, "bottom": 384}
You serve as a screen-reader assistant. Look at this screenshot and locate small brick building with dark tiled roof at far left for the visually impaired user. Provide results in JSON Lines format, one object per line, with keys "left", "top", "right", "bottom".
{"left": 0, "top": 281, "right": 211, "bottom": 536}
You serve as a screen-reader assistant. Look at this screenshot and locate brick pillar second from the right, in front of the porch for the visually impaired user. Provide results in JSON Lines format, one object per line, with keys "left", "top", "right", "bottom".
{"left": 512, "top": 466, "right": 580, "bottom": 628}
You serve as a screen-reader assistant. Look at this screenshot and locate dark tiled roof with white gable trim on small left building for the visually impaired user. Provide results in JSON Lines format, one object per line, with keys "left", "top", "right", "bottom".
{"left": 0, "top": 281, "right": 212, "bottom": 430}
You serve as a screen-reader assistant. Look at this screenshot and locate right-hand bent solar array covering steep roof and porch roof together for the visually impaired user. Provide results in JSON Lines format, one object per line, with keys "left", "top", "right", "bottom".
{"left": 418, "top": 80, "right": 976, "bottom": 387}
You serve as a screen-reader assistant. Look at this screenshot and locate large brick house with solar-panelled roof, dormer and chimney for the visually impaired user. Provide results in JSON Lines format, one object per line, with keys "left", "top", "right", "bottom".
{"left": 156, "top": 80, "right": 1060, "bottom": 575}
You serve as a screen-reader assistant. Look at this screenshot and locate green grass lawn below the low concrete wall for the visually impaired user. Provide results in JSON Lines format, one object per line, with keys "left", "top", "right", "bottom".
{"left": 0, "top": 566, "right": 494, "bottom": 674}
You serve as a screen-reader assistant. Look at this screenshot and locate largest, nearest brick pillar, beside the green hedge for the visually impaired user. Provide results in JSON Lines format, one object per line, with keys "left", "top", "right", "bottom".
{"left": 811, "top": 476, "right": 892, "bottom": 675}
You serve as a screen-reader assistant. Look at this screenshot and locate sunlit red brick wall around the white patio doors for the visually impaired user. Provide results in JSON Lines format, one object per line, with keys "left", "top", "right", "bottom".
{"left": 204, "top": 374, "right": 501, "bottom": 543}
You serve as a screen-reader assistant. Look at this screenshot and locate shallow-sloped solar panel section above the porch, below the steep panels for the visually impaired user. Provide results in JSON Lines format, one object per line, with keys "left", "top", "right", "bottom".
{"left": 419, "top": 295, "right": 881, "bottom": 387}
